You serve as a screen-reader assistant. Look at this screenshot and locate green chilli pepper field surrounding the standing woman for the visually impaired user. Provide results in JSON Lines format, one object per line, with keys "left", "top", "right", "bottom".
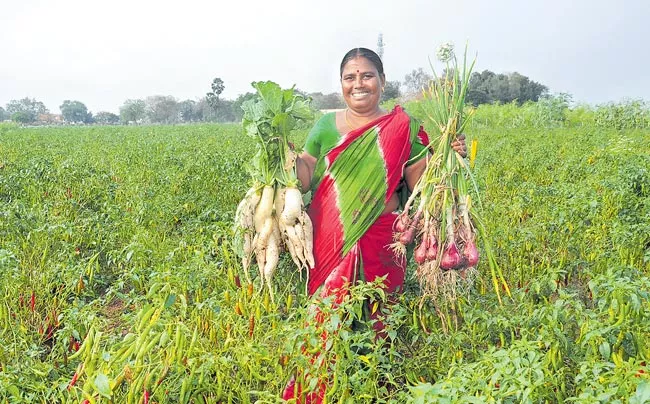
{"left": 0, "top": 106, "right": 650, "bottom": 403}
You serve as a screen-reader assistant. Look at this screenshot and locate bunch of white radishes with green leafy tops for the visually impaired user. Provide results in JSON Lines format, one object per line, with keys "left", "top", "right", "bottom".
{"left": 234, "top": 81, "right": 314, "bottom": 298}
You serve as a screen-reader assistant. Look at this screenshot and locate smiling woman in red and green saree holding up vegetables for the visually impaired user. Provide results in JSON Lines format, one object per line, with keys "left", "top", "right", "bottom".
{"left": 283, "top": 48, "right": 466, "bottom": 402}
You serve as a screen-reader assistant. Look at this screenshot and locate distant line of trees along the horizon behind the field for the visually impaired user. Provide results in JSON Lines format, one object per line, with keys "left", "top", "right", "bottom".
{"left": 0, "top": 68, "right": 548, "bottom": 125}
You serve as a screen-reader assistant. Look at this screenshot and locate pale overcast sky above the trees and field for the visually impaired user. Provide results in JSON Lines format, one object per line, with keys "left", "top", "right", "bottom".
{"left": 0, "top": 0, "right": 650, "bottom": 113}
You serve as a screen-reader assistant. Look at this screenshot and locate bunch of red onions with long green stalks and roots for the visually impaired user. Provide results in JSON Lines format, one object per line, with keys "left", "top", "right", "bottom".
{"left": 393, "top": 44, "right": 509, "bottom": 301}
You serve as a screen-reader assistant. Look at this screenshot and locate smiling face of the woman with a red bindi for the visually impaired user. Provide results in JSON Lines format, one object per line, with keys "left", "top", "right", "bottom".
{"left": 341, "top": 56, "right": 384, "bottom": 114}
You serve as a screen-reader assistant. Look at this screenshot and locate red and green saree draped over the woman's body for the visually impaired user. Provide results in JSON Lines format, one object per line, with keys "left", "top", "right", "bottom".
{"left": 308, "top": 106, "right": 426, "bottom": 300}
